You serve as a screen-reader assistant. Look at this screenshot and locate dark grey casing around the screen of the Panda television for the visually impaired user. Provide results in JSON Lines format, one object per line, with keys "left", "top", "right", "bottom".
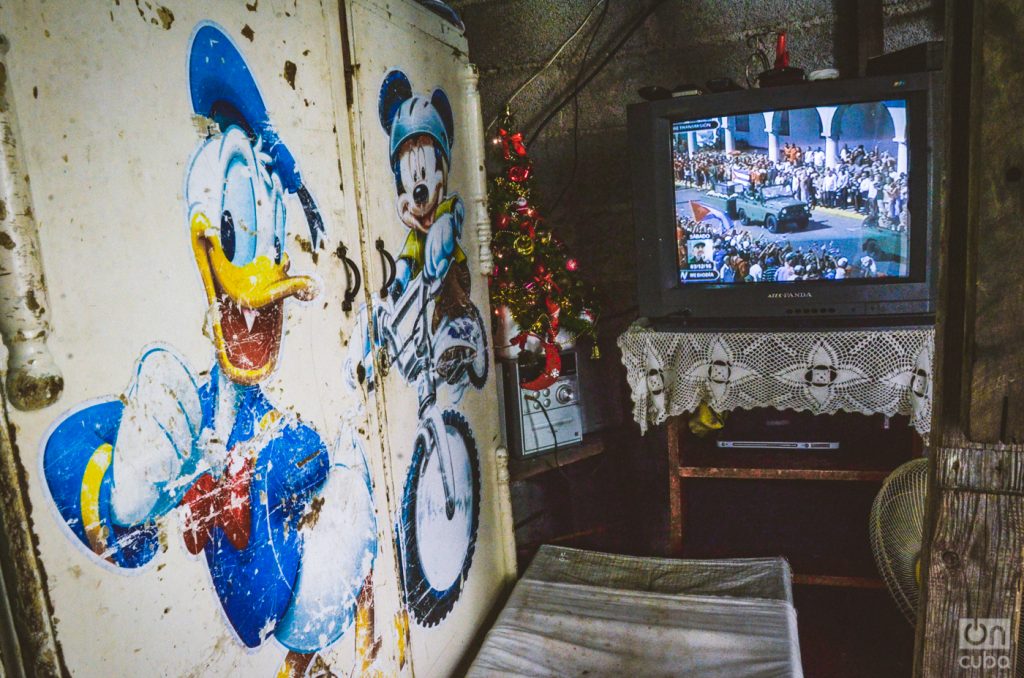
{"left": 628, "top": 72, "right": 942, "bottom": 325}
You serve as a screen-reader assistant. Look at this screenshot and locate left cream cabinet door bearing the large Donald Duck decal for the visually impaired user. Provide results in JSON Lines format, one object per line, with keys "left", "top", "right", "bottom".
{"left": 0, "top": 0, "right": 405, "bottom": 676}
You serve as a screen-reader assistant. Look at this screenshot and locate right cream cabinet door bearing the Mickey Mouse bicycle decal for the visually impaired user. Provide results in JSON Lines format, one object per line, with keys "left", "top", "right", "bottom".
{"left": 346, "top": 0, "right": 514, "bottom": 676}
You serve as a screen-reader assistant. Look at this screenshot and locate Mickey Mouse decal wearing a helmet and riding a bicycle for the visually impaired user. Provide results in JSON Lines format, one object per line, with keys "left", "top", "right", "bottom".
{"left": 368, "top": 70, "right": 489, "bottom": 628}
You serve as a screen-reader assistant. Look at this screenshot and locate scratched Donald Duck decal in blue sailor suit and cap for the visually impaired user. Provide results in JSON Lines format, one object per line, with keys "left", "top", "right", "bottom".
{"left": 41, "top": 23, "right": 377, "bottom": 676}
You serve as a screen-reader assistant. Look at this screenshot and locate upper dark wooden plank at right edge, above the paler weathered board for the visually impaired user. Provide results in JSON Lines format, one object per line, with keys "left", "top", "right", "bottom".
{"left": 950, "top": 0, "right": 1024, "bottom": 442}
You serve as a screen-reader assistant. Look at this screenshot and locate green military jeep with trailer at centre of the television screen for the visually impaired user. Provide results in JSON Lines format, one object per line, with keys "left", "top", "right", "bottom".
{"left": 701, "top": 182, "right": 811, "bottom": 234}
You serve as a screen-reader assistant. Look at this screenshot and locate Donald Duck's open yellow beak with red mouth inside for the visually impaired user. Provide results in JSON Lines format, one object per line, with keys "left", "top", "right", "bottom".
{"left": 190, "top": 212, "right": 317, "bottom": 384}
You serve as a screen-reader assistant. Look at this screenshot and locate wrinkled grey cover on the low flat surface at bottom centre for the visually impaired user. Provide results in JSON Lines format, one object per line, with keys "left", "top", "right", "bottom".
{"left": 468, "top": 546, "right": 803, "bottom": 678}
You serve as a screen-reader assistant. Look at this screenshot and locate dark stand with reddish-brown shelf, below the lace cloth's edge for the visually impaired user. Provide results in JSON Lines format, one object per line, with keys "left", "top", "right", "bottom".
{"left": 667, "top": 409, "right": 923, "bottom": 588}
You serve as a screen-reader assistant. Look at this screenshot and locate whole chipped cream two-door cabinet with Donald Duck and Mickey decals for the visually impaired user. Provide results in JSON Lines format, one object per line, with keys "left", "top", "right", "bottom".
{"left": 0, "top": 0, "right": 509, "bottom": 677}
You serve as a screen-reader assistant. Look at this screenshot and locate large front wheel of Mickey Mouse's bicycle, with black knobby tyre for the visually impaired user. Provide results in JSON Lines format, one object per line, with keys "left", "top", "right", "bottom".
{"left": 398, "top": 410, "right": 480, "bottom": 626}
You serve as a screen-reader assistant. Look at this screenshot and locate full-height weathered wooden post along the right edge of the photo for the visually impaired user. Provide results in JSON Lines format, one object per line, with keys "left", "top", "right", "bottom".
{"left": 914, "top": 0, "right": 1024, "bottom": 677}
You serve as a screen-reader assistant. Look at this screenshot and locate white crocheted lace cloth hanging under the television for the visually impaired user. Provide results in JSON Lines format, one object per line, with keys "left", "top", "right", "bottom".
{"left": 618, "top": 325, "right": 935, "bottom": 436}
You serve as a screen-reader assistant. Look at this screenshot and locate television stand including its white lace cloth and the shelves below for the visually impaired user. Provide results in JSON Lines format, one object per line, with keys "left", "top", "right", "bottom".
{"left": 618, "top": 324, "right": 935, "bottom": 587}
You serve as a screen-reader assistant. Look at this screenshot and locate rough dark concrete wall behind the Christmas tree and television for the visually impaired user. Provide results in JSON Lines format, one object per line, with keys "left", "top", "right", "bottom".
{"left": 451, "top": 0, "right": 942, "bottom": 432}
